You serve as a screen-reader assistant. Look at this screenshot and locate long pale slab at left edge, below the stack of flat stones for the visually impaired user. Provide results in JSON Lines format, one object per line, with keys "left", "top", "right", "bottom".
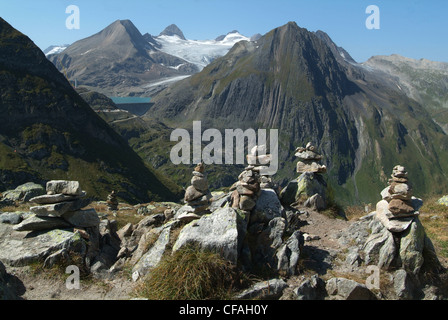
{"left": 0, "top": 229, "right": 86, "bottom": 266}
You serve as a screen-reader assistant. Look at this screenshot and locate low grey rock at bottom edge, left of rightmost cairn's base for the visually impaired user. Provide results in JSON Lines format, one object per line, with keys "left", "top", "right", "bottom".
{"left": 326, "top": 278, "right": 376, "bottom": 300}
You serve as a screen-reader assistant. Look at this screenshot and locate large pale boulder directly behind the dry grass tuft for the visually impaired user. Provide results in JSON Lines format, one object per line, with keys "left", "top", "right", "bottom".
{"left": 173, "top": 208, "right": 246, "bottom": 264}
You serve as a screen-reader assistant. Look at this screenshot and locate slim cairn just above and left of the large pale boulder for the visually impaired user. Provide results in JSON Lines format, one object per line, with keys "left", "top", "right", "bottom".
{"left": 177, "top": 163, "right": 212, "bottom": 220}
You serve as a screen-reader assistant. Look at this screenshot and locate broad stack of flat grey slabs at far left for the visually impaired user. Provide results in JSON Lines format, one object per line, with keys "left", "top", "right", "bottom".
{"left": 14, "top": 180, "right": 100, "bottom": 231}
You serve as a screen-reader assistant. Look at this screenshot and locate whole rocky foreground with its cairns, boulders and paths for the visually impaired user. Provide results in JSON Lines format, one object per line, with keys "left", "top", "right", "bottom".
{"left": 0, "top": 161, "right": 448, "bottom": 300}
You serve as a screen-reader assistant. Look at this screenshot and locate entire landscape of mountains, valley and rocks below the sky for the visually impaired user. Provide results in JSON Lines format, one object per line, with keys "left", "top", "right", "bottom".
{"left": 0, "top": 10, "right": 448, "bottom": 300}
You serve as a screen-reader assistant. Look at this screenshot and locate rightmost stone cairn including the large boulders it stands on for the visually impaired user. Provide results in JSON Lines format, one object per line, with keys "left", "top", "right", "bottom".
{"left": 364, "top": 165, "right": 440, "bottom": 276}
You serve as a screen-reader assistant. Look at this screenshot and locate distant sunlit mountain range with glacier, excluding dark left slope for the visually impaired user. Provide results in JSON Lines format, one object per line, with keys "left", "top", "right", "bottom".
{"left": 2, "top": 20, "right": 448, "bottom": 203}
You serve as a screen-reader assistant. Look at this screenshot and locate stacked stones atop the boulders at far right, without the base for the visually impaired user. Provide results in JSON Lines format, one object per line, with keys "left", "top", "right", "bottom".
{"left": 376, "top": 165, "right": 423, "bottom": 232}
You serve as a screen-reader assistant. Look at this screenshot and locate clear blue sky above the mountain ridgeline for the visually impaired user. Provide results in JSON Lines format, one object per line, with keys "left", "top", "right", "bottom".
{"left": 0, "top": 0, "right": 448, "bottom": 62}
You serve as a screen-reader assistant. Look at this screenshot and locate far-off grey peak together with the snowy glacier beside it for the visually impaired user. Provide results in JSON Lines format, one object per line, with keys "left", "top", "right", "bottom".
{"left": 45, "top": 20, "right": 254, "bottom": 96}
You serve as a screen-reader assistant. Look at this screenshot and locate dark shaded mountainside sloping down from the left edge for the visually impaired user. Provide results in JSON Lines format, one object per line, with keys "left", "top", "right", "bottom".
{"left": 0, "top": 19, "right": 182, "bottom": 201}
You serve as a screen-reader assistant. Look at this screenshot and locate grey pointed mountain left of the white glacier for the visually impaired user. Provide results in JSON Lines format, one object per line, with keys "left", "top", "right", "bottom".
{"left": 48, "top": 20, "right": 197, "bottom": 95}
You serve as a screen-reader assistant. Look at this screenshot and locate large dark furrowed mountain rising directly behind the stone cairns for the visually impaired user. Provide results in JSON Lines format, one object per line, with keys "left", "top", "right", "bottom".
{"left": 147, "top": 22, "right": 448, "bottom": 202}
